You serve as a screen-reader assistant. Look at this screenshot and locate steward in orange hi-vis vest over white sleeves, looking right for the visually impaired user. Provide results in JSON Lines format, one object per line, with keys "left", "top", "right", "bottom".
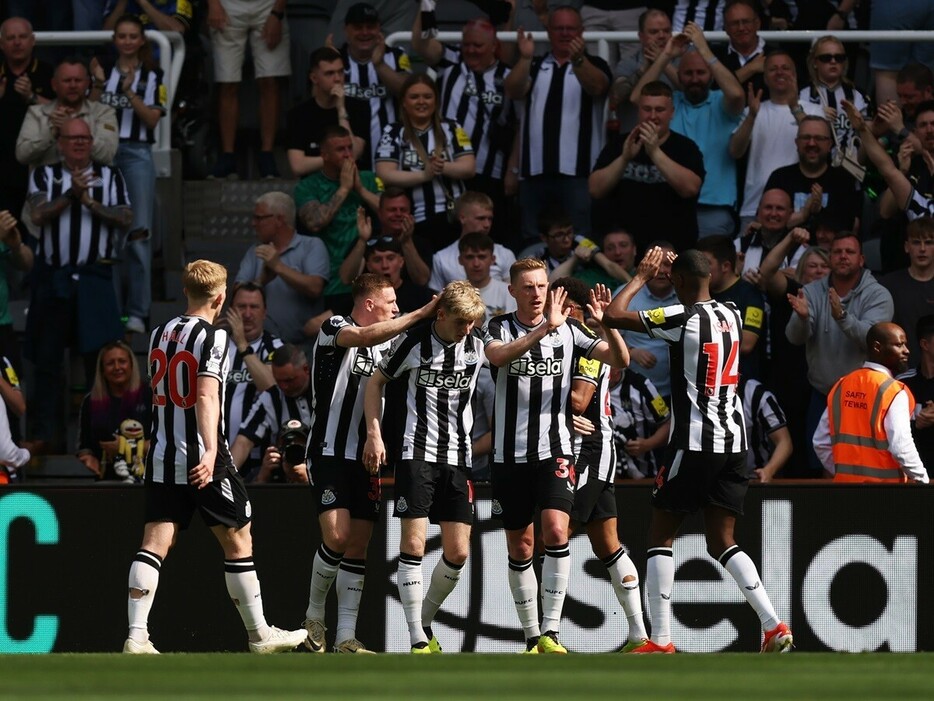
{"left": 814, "top": 322, "right": 928, "bottom": 484}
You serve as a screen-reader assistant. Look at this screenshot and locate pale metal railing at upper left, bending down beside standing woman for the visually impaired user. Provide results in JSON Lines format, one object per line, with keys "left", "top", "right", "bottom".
{"left": 36, "top": 29, "right": 185, "bottom": 178}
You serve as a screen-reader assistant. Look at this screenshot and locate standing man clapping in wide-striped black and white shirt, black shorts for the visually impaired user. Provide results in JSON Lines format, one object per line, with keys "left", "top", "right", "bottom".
{"left": 505, "top": 5, "right": 612, "bottom": 241}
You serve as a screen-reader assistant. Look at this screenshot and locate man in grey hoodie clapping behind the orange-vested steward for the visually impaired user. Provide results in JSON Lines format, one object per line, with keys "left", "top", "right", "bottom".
{"left": 785, "top": 231, "right": 895, "bottom": 477}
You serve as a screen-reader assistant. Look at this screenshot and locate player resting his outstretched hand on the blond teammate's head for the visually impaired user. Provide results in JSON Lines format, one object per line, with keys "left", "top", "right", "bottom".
{"left": 304, "top": 273, "right": 435, "bottom": 654}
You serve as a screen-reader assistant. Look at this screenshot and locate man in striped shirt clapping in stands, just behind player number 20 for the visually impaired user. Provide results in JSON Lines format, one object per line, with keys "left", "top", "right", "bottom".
{"left": 221, "top": 282, "right": 283, "bottom": 474}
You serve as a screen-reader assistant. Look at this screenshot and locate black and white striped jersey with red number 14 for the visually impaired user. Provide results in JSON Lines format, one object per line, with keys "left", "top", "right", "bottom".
{"left": 639, "top": 300, "right": 746, "bottom": 454}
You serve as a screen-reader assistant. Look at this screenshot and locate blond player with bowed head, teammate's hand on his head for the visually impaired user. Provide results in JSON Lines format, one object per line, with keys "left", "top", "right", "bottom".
{"left": 363, "top": 280, "right": 486, "bottom": 654}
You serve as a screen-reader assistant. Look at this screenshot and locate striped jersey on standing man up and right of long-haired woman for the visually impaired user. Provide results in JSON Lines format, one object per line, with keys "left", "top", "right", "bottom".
{"left": 436, "top": 45, "right": 516, "bottom": 179}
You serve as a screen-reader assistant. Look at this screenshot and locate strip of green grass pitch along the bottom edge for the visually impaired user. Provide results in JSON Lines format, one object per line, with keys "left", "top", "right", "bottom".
{"left": 0, "top": 653, "right": 934, "bottom": 701}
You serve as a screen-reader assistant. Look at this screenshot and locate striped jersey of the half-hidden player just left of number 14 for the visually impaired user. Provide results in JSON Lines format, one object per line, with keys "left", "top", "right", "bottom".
{"left": 571, "top": 356, "right": 616, "bottom": 486}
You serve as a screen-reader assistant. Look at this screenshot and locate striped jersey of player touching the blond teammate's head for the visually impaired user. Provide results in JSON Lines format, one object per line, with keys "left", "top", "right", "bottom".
{"left": 308, "top": 316, "right": 391, "bottom": 461}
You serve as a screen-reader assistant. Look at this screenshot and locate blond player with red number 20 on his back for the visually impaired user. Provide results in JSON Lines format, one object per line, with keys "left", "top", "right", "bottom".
{"left": 123, "top": 260, "right": 305, "bottom": 655}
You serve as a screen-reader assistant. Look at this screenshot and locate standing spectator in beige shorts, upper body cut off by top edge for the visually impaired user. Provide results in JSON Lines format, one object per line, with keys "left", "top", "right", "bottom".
{"left": 207, "top": 0, "right": 292, "bottom": 178}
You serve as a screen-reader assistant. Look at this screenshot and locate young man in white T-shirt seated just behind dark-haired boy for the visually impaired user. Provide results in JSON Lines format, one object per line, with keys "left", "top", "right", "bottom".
{"left": 428, "top": 190, "right": 516, "bottom": 291}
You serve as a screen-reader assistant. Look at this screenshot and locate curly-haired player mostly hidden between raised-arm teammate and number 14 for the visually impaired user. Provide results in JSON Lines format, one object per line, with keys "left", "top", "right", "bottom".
{"left": 551, "top": 277, "right": 648, "bottom": 652}
